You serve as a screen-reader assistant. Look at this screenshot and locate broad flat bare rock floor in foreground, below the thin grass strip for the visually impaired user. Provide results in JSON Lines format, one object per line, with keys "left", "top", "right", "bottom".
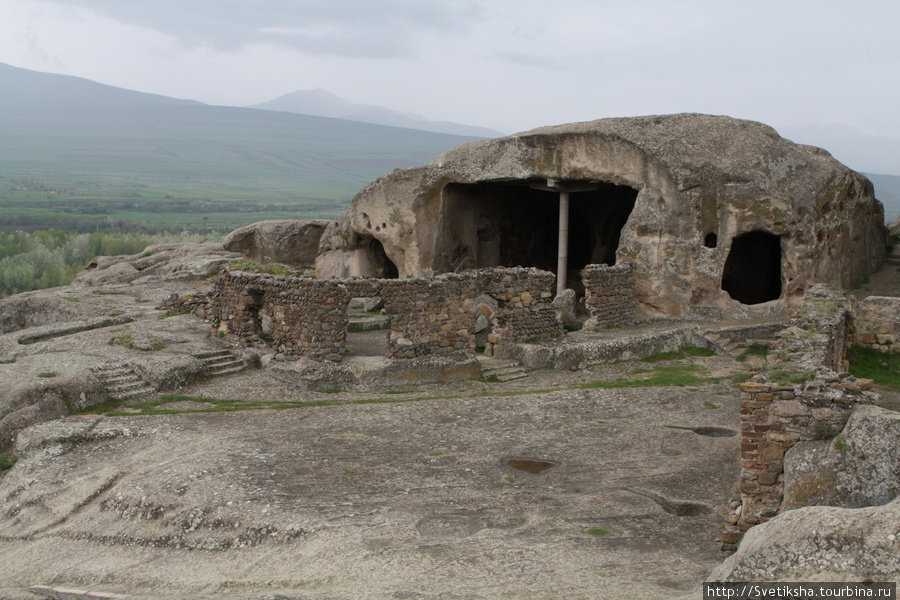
{"left": 0, "top": 382, "right": 739, "bottom": 600}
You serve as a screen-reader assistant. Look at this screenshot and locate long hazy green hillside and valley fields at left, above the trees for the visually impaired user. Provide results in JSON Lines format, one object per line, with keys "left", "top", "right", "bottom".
{"left": 0, "top": 64, "right": 471, "bottom": 231}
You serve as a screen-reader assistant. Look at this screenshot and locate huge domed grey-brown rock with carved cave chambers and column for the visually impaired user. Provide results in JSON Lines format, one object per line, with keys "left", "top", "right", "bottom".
{"left": 316, "top": 114, "right": 886, "bottom": 319}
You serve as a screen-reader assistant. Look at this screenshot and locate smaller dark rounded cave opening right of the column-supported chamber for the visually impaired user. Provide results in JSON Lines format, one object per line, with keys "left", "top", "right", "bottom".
{"left": 722, "top": 231, "right": 781, "bottom": 304}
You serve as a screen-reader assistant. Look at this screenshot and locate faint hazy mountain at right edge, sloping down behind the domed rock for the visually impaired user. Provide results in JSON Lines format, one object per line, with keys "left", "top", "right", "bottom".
{"left": 778, "top": 124, "right": 900, "bottom": 175}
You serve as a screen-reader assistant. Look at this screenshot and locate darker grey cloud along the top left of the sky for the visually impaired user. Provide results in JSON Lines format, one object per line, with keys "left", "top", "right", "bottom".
{"left": 45, "top": 0, "right": 481, "bottom": 58}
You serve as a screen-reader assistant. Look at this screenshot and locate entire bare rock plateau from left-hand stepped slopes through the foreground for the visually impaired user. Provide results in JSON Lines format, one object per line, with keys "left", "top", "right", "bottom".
{"left": 0, "top": 229, "right": 897, "bottom": 600}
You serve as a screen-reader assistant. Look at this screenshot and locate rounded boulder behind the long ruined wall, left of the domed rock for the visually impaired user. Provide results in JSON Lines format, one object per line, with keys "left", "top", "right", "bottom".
{"left": 223, "top": 219, "right": 330, "bottom": 266}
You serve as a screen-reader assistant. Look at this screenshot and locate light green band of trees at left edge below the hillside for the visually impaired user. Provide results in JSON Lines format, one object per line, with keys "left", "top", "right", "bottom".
{"left": 0, "top": 229, "right": 218, "bottom": 297}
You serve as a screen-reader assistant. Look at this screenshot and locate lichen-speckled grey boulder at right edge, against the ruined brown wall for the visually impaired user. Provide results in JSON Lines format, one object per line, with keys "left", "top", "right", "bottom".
{"left": 781, "top": 405, "right": 900, "bottom": 511}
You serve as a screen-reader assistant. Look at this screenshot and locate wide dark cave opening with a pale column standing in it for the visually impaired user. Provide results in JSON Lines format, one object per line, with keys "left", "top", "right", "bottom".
{"left": 435, "top": 180, "right": 637, "bottom": 291}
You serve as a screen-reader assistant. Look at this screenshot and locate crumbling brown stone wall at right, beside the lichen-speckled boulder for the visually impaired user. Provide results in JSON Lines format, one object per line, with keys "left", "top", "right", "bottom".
{"left": 726, "top": 286, "right": 877, "bottom": 539}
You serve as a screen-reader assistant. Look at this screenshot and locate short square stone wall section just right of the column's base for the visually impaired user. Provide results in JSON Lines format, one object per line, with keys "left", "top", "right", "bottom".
{"left": 581, "top": 263, "right": 634, "bottom": 328}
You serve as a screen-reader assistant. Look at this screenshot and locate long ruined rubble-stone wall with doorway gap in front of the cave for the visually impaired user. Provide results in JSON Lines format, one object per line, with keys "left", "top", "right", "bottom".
{"left": 207, "top": 268, "right": 561, "bottom": 362}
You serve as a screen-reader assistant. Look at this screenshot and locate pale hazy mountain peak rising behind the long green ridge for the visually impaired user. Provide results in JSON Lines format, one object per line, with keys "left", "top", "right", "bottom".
{"left": 248, "top": 88, "right": 504, "bottom": 138}
